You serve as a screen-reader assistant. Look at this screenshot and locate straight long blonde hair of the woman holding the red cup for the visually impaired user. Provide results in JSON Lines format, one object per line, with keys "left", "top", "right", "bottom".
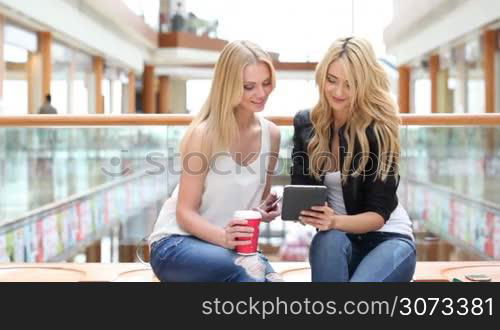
{"left": 181, "top": 41, "right": 276, "bottom": 159}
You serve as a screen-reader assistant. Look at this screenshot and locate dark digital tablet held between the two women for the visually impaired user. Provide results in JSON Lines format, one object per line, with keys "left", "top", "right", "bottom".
{"left": 281, "top": 185, "right": 327, "bottom": 221}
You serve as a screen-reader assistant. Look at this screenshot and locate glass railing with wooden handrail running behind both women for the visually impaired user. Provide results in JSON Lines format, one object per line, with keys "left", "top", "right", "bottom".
{"left": 0, "top": 116, "right": 500, "bottom": 262}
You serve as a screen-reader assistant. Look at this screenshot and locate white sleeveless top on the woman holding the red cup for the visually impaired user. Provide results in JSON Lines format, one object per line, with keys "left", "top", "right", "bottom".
{"left": 149, "top": 115, "right": 271, "bottom": 244}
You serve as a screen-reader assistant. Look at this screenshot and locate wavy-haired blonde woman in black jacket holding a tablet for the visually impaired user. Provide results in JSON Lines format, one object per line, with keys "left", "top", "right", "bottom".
{"left": 291, "top": 37, "right": 416, "bottom": 282}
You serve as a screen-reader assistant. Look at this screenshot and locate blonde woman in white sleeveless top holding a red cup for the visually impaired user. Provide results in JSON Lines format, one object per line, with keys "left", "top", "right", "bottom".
{"left": 149, "top": 41, "right": 280, "bottom": 282}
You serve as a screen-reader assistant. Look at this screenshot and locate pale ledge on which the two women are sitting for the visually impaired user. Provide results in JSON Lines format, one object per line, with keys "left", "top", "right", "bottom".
{"left": 0, "top": 261, "right": 500, "bottom": 282}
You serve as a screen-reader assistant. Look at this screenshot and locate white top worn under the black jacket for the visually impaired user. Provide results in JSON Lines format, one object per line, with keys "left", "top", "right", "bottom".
{"left": 325, "top": 171, "right": 414, "bottom": 239}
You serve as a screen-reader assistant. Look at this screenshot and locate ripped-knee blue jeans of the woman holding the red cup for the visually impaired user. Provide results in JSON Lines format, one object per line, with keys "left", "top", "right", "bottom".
{"left": 150, "top": 235, "right": 275, "bottom": 282}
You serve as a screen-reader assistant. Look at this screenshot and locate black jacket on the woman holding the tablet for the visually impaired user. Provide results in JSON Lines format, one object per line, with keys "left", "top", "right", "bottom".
{"left": 290, "top": 110, "right": 399, "bottom": 221}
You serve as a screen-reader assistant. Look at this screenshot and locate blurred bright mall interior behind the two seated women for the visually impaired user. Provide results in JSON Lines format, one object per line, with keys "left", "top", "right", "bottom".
{"left": 0, "top": 0, "right": 500, "bottom": 262}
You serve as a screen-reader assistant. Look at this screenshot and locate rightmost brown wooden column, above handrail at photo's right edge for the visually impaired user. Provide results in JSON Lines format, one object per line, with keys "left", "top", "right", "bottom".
{"left": 483, "top": 30, "right": 497, "bottom": 113}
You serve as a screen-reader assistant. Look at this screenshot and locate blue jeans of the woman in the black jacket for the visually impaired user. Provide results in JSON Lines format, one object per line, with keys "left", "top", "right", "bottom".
{"left": 309, "top": 230, "right": 416, "bottom": 282}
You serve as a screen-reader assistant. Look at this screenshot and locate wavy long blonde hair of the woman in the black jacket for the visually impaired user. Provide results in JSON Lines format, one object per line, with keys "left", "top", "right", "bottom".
{"left": 308, "top": 37, "right": 401, "bottom": 183}
